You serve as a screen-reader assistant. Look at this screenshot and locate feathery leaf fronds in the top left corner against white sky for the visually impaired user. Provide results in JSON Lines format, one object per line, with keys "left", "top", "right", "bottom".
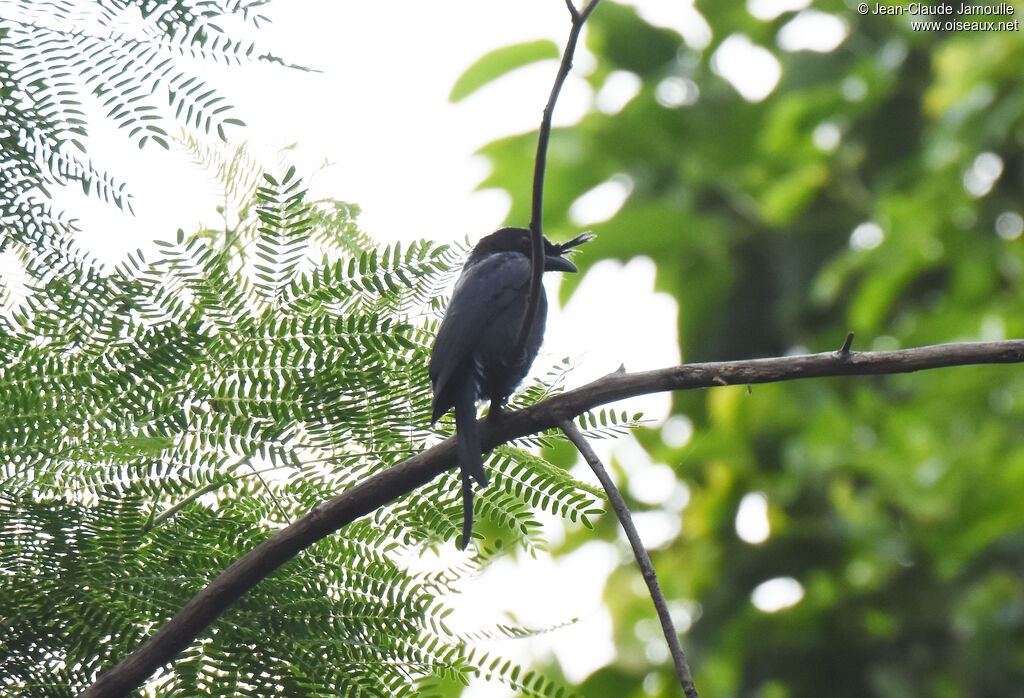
{"left": 0, "top": 0, "right": 281, "bottom": 255}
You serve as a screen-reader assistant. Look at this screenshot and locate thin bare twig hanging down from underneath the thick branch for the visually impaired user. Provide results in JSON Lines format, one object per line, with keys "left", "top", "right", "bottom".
{"left": 559, "top": 420, "right": 697, "bottom": 698}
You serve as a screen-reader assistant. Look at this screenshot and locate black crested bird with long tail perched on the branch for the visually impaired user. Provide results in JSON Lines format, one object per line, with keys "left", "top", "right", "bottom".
{"left": 430, "top": 228, "right": 593, "bottom": 549}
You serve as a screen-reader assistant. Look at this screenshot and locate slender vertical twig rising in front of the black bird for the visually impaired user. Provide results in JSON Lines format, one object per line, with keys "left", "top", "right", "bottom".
{"left": 509, "top": 0, "right": 600, "bottom": 361}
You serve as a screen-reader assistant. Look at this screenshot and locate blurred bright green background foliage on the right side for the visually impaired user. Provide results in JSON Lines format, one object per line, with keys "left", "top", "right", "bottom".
{"left": 468, "top": 0, "right": 1024, "bottom": 698}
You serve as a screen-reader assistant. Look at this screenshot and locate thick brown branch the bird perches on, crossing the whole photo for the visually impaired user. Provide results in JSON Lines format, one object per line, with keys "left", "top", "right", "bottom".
{"left": 80, "top": 340, "right": 1024, "bottom": 698}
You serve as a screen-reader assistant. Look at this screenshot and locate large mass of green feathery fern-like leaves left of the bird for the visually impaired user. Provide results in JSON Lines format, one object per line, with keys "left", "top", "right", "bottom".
{"left": 0, "top": 152, "right": 600, "bottom": 696}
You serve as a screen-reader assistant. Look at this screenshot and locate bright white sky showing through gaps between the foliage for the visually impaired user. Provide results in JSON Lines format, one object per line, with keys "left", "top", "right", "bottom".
{"left": 39, "top": 0, "right": 823, "bottom": 697}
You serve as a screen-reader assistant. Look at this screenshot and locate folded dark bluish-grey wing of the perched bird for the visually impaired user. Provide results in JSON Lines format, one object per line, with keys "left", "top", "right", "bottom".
{"left": 430, "top": 253, "right": 529, "bottom": 420}
